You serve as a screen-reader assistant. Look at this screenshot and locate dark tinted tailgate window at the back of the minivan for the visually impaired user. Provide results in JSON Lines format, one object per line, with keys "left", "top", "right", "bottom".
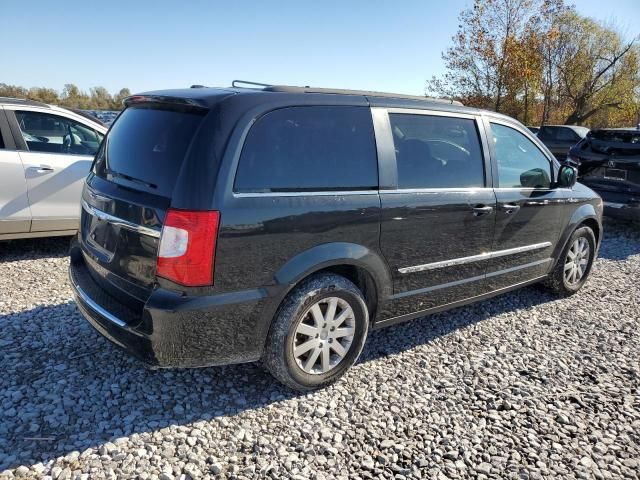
{"left": 95, "top": 106, "right": 203, "bottom": 197}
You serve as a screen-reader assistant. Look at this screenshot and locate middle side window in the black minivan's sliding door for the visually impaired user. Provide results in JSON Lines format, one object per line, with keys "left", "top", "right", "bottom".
{"left": 389, "top": 113, "right": 484, "bottom": 188}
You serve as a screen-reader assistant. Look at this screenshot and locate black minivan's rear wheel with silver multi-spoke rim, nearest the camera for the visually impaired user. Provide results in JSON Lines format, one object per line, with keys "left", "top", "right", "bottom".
{"left": 263, "top": 273, "right": 369, "bottom": 391}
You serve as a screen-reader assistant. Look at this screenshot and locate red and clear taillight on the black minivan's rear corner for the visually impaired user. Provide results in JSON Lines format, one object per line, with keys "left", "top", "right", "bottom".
{"left": 156, "top": 210, "right": 220, "bottom": 287}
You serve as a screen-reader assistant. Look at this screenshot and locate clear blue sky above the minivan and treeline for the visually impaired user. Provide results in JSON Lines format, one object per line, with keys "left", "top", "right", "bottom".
{"left": 0, "top": 0, "right": 640, "bottom": 95}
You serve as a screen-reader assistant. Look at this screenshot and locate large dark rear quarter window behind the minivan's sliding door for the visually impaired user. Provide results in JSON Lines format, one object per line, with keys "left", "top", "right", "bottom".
{"left": 235, "top": 106, "right": 378, "bottom": 192}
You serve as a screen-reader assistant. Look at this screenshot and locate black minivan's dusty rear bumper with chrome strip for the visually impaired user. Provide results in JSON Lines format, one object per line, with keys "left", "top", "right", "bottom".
{"left": 69, "top": 260, "right": 269, "bottom": 367}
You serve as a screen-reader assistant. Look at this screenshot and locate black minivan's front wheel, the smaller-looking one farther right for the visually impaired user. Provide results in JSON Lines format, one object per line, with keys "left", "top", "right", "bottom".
{"left": 545, "top": 226, "right": 596, "bottom": 297}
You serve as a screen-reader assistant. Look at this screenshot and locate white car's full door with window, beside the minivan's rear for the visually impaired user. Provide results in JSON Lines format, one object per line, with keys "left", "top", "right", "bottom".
{"left": 8, "top": 107, "right": 102, "bottom": 232}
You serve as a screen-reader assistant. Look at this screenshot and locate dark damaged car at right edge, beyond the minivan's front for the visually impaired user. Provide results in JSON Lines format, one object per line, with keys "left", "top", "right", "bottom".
{"left": 568, "top": 125, "right": 640, "bottom": 221}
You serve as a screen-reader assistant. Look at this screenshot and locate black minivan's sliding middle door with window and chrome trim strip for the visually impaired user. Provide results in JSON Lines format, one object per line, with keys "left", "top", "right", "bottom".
{"left": 373, "top": 108, "right": 496, "bottom": 319}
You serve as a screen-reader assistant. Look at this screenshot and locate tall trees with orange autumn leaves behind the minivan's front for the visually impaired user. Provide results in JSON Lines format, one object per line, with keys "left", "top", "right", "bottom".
{"left": 426, "top": 0, "right": 640, "bottom": 127}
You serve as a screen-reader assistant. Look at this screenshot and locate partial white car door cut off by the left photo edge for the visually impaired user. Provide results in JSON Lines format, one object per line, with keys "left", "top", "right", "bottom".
{"left": 0, "top": 107, "right": 31, "bottom": 238}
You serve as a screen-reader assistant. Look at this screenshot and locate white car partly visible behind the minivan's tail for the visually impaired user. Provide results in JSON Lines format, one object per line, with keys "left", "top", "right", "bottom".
{"left": 0, "top": 98, "right": 107, "bottom": 240}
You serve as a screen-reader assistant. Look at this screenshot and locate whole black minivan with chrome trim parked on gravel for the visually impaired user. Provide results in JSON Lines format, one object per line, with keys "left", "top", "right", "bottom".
{"left": 70, "top": 82, "right": 602, "bottom": 390}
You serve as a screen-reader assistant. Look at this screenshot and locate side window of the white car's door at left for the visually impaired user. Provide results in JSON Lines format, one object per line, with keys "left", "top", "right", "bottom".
{"left": 15, "top": 111, "right": 103, "bottom": 155}
